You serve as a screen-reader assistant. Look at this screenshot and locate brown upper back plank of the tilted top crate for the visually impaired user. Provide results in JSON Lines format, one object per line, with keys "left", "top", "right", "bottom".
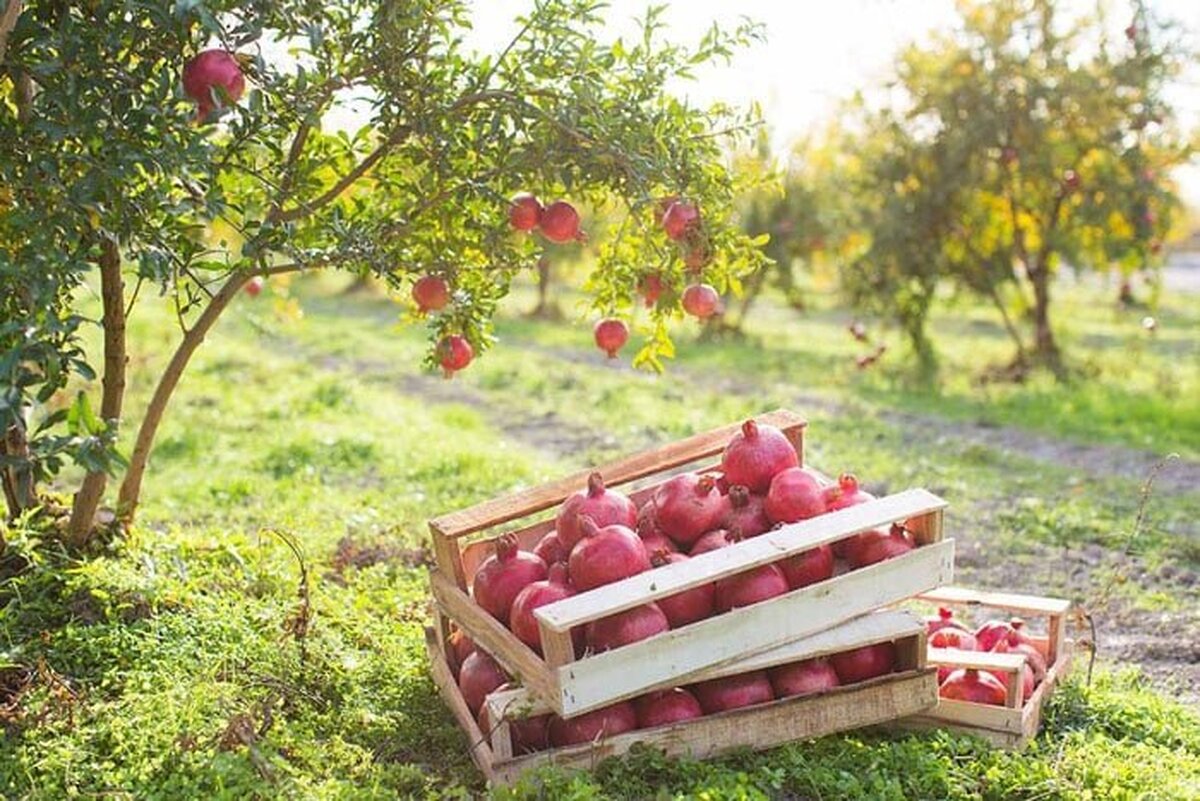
{"left": 431, "top": 410, "right": 806, "bottom": 538}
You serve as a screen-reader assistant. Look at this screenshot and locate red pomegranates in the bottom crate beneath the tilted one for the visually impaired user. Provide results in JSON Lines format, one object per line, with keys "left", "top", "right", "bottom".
{"left": 445, "top": 630, "right": 898, "bottom": 754}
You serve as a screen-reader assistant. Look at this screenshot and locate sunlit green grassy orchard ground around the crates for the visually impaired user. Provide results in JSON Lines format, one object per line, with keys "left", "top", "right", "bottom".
{"left": 0, "top": 272, "right": 1200, "bottom": 799}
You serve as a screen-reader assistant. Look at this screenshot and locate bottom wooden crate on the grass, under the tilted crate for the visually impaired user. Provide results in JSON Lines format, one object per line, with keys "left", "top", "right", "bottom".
{"left": 426, "top": 612, "right": 937, "bottom": 784}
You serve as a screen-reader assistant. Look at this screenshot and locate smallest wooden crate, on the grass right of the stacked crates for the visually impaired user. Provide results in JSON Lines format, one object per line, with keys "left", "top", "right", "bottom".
{"left": 901, "top": 586, "right": 1072, "bottom": 751}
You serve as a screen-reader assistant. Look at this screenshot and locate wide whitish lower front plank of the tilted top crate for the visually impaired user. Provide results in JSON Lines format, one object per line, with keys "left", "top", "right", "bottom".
{"left": 549, "top": 540, "right": 954, "bottom": 717}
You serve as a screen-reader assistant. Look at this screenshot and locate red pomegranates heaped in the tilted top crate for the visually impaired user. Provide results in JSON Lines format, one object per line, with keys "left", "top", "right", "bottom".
{"left": 472, "top": 420, "right": 914, "bottom": 655}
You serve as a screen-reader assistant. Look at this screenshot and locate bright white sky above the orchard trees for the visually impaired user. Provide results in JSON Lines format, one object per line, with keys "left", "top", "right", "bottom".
{"left": 468, "top": 0, "right": 1200, "bottom": 207}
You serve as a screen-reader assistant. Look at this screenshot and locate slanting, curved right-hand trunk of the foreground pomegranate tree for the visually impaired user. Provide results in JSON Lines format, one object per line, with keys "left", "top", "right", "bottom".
{"left": 116, "top": 271, "right": 253, "bottom": 525}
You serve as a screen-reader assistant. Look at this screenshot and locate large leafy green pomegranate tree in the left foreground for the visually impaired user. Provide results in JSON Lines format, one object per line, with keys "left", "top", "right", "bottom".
{"left": 0, "top": 0, "right": 761, "bottom": 543}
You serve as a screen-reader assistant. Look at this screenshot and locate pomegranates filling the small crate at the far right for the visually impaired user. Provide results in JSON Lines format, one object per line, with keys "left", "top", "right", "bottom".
{"left": 925, "top": 607, "right": 1046, "bottom": 706}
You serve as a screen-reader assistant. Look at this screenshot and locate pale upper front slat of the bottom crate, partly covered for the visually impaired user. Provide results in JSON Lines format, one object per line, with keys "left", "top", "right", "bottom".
{"left": 488, "top": 609, "right": 925, "bottom": 716}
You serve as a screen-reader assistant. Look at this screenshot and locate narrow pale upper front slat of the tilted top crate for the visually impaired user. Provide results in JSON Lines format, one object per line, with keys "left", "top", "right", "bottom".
{"left": 534, "top": 489, "right": 946, "bottom": 631}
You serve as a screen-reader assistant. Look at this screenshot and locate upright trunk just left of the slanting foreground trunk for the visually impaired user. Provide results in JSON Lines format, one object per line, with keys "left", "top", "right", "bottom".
{"left": 67, "top": 239, "right": 127, "bottom": 548}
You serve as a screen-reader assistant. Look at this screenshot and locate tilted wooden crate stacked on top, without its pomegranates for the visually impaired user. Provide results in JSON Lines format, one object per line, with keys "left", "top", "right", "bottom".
{"left": 430, "top": 411, "right": 954, "bottom": 717}
